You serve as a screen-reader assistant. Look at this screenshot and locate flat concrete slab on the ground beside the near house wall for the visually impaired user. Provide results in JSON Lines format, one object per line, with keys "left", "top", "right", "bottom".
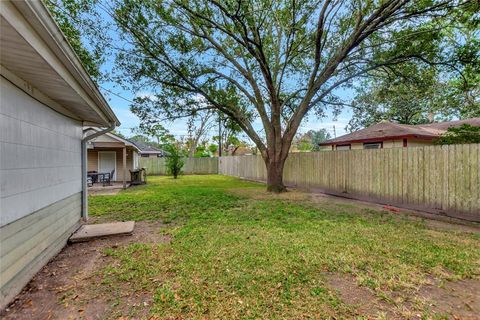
{"left": 68, "top": 221, "right": 135, "bottom": 242}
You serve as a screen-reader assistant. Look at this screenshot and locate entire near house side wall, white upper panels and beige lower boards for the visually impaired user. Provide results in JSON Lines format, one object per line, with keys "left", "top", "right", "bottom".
{"left": 0, "top": 76, "right": 82, "bottom": 308}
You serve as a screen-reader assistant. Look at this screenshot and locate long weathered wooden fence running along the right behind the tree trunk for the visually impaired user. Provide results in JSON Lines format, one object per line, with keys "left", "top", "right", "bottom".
{"left": 218, "top": 144, "right": 480, "bottom": 221}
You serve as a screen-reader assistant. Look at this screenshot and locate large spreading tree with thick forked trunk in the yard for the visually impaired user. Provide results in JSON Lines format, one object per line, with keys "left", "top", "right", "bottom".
{"left": 80, "top": 0, "right": 469, "bottom": 192}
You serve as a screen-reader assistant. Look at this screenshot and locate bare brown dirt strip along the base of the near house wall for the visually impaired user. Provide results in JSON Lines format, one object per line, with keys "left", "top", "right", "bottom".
{"left": 0, "top": 222, "right": 170, "bottom": 319}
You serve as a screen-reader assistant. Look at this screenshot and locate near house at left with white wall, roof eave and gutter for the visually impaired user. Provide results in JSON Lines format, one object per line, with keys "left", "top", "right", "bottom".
{"left": 0, "top": 1, "right": 119, "bottom": 308}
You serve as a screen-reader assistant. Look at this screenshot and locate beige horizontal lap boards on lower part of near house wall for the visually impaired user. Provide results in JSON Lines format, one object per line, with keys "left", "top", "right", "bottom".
{"left": 0, "top": 193, "right": 82, "bottom": 309}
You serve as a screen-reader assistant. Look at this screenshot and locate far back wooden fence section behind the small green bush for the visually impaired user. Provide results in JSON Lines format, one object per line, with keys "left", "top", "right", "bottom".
{"left": 139, "top": 158, "right": 218, "bottom": 175}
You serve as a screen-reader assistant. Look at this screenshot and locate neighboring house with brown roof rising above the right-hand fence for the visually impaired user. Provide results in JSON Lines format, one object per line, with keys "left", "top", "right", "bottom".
{"left": 319, "top": 118, "right": 480, "bottom": 150}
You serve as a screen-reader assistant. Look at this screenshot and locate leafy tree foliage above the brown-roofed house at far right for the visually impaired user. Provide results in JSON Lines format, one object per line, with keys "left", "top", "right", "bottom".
{"left": 347, "top": 1, "right": 480, "bottom": 131}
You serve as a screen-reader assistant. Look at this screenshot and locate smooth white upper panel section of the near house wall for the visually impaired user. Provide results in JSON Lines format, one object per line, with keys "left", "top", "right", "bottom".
{"left": 0, "top": 77, "right": 82, "bottom": 226}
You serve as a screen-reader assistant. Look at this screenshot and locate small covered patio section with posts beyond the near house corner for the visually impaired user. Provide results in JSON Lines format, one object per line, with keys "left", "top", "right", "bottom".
{"left": 87, "top": 128, "right": 140, "bottom": 187}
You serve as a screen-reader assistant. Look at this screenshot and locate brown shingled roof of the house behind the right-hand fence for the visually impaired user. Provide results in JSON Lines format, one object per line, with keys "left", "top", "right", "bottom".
{"left": 320, "top": 118, "right": 480, "bottom": 146}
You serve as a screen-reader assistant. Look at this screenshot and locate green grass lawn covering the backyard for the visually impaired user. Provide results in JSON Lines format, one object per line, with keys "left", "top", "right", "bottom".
{"left": 89, "top": 175, "right": 480, "bottom": 319}
